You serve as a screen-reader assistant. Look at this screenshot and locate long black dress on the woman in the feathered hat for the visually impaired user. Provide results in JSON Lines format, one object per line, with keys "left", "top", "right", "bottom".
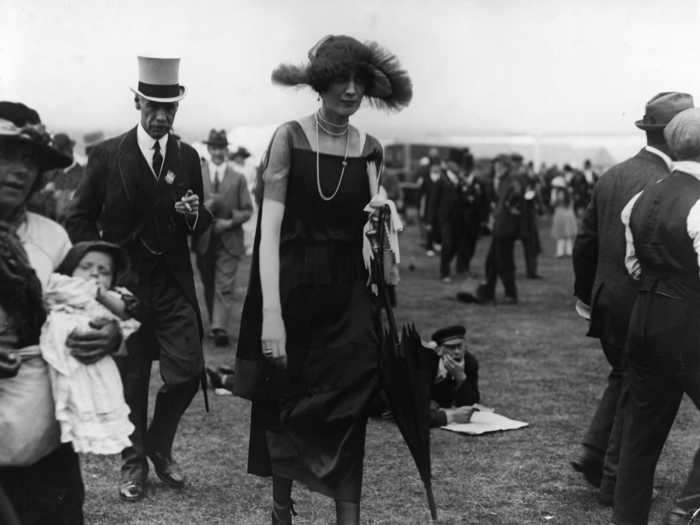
{"left": 235, "top": 122, "right": 381, "bottom": 501}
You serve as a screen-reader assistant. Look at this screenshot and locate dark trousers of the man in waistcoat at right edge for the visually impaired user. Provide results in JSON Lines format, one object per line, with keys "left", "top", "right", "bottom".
{"left": 613, "top": 292, "right": 700, "bottom": 525}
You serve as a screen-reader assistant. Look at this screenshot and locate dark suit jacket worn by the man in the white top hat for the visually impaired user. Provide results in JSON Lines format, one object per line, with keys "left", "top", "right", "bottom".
{"left": 66, "top": 128, "right": 211, "bottom": 324}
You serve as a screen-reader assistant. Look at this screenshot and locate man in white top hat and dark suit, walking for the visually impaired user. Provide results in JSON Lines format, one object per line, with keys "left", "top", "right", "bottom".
{"left": 66, "top": 57, "right": 211, "bottom": 501}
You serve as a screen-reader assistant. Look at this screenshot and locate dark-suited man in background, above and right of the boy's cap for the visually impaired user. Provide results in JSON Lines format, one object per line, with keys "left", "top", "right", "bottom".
{"left": 476, "top": 155, "right": 524, "bottom": 304}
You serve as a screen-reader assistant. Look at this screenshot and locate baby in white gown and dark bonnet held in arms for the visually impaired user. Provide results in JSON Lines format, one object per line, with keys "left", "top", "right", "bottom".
{"left": 39, "top": 241, "right": 140, "bottom": 454}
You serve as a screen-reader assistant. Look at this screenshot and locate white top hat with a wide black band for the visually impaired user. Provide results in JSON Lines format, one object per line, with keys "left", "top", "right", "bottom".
{"left": 130, "top": 57, "right": 185, "bottom": 102}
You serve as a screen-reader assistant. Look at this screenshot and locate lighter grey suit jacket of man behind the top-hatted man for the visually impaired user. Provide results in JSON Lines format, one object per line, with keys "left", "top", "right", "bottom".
{"left": 195, "top": 161, "right": 253, "bottom": 256}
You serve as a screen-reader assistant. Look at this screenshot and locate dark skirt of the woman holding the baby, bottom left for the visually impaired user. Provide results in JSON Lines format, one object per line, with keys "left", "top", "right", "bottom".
{"left": 0, "top": 443, "right": 85, "bottom": 525}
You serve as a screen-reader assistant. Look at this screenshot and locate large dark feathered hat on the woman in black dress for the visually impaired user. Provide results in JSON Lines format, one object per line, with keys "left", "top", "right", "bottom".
{"left": 272, "top": 35, "right": 413, "bottom": 111}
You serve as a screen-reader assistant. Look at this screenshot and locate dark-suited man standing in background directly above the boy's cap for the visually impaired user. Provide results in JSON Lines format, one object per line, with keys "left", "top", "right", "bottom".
{"left": 430, "top": 148, "right": 464, "bottom": 283}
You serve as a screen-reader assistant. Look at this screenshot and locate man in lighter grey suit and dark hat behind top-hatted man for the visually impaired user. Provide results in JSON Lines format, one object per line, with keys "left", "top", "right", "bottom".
{"left": 194, "top": 129, "right": 253, "bottom": 346}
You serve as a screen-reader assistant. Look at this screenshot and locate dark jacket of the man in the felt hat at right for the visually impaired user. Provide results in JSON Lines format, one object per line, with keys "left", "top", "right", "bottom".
{"left": 573, "top": 149, "right": 669, "bottom": 347}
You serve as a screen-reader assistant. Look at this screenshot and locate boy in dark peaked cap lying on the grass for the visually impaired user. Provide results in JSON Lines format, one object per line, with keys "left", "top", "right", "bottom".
{"left": 430, "top": 325, "right": 479, "bottom": 427}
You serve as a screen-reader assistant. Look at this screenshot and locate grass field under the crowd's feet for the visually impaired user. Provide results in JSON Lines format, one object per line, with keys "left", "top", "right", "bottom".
{"left": 83, "top": 219, "right": 700, "bottom": 525}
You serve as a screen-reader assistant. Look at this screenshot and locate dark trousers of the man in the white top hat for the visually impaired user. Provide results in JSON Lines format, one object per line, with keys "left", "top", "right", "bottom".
{"left": 116, "top": 271, "right": 203, "bottom": 479}
